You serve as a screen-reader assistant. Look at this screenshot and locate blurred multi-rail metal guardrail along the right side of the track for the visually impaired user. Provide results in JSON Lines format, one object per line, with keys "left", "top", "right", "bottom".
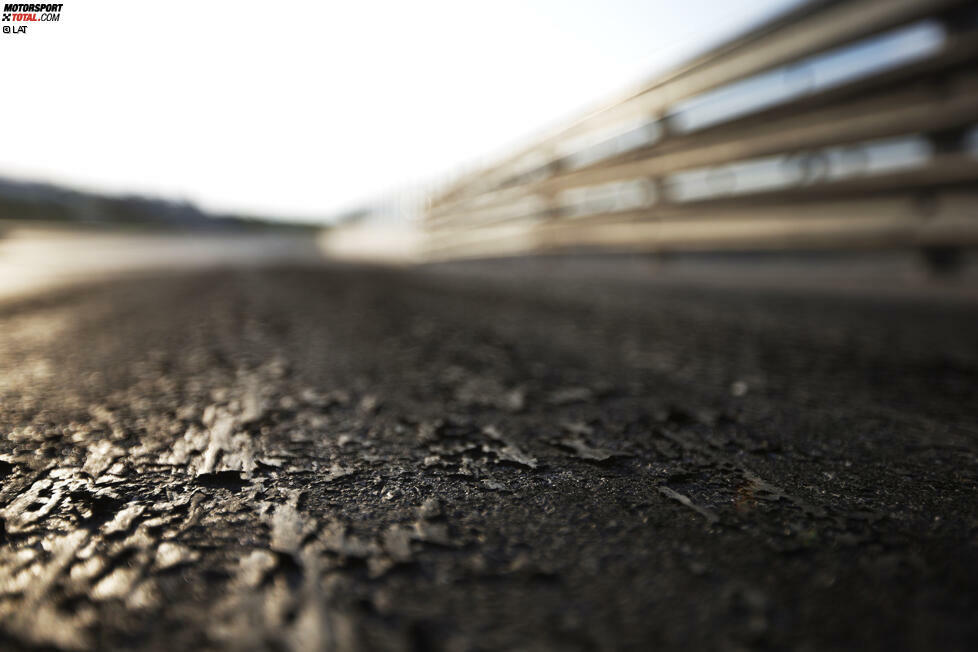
{"left": 424, "top": 0, "right": 978, "bottom": 260}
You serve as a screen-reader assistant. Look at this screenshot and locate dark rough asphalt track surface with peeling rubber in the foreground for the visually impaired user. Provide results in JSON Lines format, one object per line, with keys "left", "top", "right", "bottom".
{"left": 0, "top": 268, "right": 978, "bottom": 650}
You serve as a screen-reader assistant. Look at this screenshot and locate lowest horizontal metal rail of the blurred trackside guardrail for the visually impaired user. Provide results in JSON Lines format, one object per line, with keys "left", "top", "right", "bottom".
{"left": 427, "top": 191, "right": 978, "bottom": 260}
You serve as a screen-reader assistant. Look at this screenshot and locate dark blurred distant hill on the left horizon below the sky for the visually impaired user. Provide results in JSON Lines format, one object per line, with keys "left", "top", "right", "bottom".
{"left": 0, "top": 177, "right": 318, "bottom": 230}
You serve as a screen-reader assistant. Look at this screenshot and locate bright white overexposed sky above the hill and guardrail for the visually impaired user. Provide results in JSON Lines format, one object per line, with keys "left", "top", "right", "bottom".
{"left": 0, "top": 0, "right": 798, "bottom": 219}
